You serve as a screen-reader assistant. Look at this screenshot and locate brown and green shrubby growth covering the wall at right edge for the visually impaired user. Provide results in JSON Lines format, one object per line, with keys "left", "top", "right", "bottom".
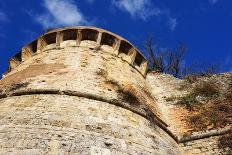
{"left": 169, "top": 77, "right": 232, "bottom": 131}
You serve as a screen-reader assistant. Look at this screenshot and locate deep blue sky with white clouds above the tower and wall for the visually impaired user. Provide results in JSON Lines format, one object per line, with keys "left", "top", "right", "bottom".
{"left": 0, "top": 0, "right": 232, "bottom": 77}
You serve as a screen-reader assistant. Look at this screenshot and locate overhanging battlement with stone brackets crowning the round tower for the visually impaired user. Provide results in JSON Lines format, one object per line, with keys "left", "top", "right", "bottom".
{"left": 5, "top": 26, "right": 148, "bottom": 76}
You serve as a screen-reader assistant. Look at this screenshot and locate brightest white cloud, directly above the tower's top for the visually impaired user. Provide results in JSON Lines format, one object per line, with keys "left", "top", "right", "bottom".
{"left": 36, "top": 0, "right": 87, "bottom": 28}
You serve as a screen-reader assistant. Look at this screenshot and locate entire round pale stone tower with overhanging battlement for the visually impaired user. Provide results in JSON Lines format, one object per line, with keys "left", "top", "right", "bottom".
{"left": 0, "top": 27, "right": 181, "bottom": 155}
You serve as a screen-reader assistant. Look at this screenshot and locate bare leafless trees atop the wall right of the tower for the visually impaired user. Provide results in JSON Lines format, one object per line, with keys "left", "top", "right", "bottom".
{"left": 145, "top": 37, "right": 220, "bottom": 78}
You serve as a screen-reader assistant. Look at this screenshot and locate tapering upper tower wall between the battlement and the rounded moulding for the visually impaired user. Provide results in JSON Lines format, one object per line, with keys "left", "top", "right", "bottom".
{"left": 0, "top": 44, "right": 160, "bottom": 120}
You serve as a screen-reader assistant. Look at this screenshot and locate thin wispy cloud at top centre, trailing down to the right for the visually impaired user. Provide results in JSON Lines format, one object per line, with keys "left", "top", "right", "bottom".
{"left": 112, "top": 0, "right": 178, "bottom": 31}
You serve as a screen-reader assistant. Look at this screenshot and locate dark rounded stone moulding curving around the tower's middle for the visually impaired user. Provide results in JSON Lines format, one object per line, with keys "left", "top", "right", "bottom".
{"left": 0, "top": 89, "right": 174, "bottom": 141}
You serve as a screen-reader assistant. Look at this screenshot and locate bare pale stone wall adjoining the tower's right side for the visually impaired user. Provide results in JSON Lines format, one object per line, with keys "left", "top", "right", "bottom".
{"left": 146, "top": 72, "right": 232, "bottom": 155}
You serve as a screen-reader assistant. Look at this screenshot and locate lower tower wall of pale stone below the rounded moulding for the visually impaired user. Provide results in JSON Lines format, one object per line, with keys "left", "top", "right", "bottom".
{"left": 0, "top": 94, "right": 180, "bottom": 155}
